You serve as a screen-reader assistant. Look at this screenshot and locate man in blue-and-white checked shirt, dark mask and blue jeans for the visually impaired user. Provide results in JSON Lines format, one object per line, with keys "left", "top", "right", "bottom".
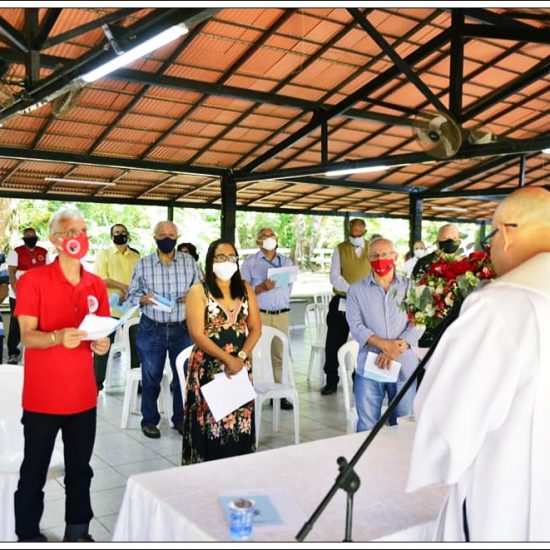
{"left": 128, "top": 221, "right": 201, "bottom": 439}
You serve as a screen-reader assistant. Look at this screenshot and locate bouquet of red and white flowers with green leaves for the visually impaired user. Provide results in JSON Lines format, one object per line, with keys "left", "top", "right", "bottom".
{"left": 403, "top": 252, "right": 496, "bottom": 329}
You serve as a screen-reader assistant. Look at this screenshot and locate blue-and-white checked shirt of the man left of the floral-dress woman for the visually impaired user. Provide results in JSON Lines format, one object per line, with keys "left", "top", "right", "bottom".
{"left": 128, "top": 252, "right": 201, "bottom": 323}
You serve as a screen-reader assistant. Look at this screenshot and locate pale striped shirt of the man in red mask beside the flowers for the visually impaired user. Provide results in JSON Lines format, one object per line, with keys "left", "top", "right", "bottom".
{"left": 346, "top": 273, "right": 423, "bottom": 380}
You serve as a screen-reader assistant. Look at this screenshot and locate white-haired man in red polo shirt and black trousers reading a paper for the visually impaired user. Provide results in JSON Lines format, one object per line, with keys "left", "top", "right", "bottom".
{"left": 15, "top": 209, "right": 110, "bottom": 542}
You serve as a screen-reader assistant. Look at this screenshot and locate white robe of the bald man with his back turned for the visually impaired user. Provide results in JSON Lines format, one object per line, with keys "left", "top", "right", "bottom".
{"left": 407, "top": 253, "right": 550, "bottom": 541}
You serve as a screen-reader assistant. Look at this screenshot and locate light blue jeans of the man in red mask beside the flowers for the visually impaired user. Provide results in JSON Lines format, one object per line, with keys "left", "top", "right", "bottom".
{"left": 354, "top": 375, "right": 416, "bottom": 432}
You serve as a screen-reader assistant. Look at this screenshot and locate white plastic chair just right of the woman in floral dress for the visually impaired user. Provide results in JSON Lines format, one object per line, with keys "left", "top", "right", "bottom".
{"left": 252, "top": 327, "right": 300, "bottom": 445}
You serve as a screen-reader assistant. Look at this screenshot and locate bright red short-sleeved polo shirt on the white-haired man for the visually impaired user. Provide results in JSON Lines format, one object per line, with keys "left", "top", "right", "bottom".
{"left": 14, "top": 259, "right": 110, "bottom": 414}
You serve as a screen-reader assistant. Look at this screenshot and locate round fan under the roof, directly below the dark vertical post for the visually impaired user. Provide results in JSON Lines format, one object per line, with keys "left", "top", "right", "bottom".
{"left": 413, "top": 111, "right": 462, "bottom": 159}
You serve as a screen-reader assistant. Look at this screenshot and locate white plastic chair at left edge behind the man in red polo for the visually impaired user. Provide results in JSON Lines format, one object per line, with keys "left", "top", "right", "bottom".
{"left": 0, "top": 365, "right": 64, "bottom": 542}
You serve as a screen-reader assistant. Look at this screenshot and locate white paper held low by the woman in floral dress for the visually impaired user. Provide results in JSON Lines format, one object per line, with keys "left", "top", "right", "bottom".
{"left": 201, "top": 368, "right": 256, "bottom": 422}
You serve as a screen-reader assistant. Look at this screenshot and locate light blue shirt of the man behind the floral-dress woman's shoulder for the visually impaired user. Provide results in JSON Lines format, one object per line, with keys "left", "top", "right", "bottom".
{"left": 241, "top": 250, "right": 294, "bottom": 311}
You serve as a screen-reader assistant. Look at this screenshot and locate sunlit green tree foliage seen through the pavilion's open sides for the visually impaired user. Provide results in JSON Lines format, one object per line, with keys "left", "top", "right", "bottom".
{"left": 4, "top": 199, "right": 488, "bottom": 270}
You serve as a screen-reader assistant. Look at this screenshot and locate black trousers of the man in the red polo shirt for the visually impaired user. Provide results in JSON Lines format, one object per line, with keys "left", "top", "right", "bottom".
{"left": 15, "top": 408, "right": 96, "bottom": 541}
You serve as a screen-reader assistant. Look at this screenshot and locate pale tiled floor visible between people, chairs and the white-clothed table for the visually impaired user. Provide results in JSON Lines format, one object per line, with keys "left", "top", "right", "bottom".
{"left": 41, "top": 329, "right": 354, "bottom": 542}
